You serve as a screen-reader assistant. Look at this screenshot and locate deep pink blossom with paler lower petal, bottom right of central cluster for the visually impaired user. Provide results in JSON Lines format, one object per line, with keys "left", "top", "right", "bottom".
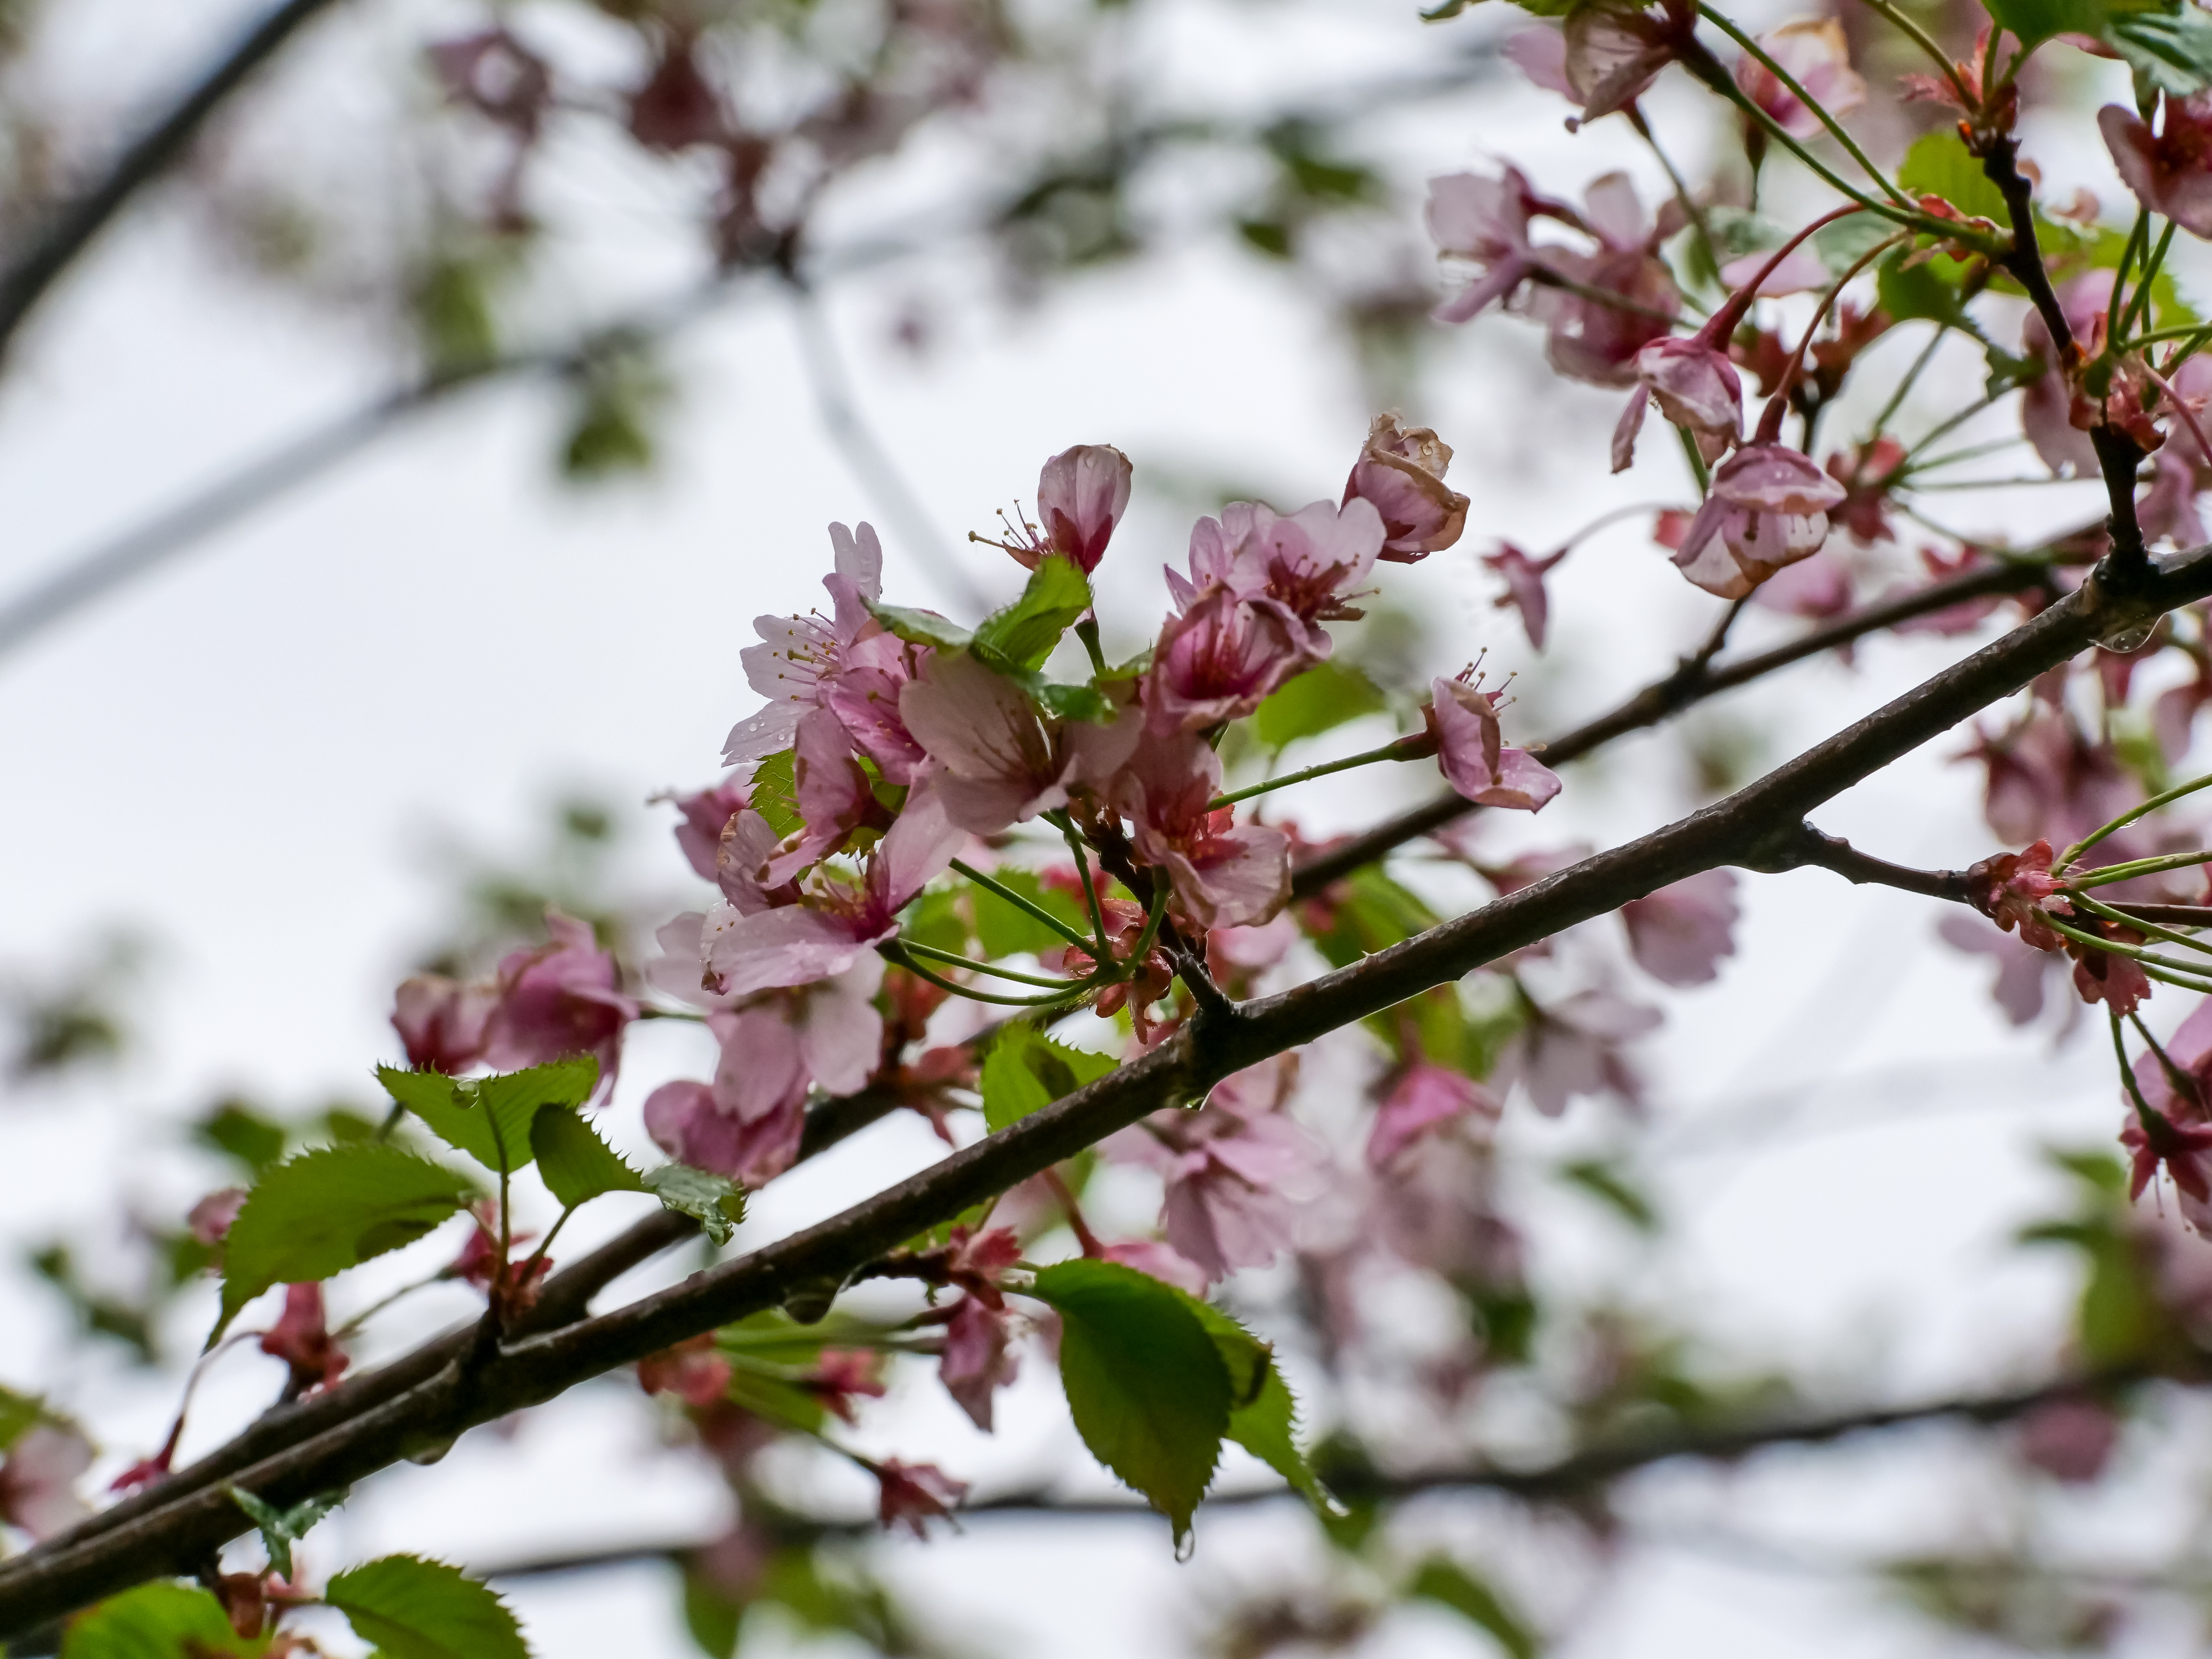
{"left": 1113, "top": 732, "right": 1289, "bottom": 927}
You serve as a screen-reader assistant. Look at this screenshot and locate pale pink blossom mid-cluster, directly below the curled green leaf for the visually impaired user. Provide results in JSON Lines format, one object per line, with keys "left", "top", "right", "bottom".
{"left": 898, "top": 652, "right": 1144, "bottom": 836}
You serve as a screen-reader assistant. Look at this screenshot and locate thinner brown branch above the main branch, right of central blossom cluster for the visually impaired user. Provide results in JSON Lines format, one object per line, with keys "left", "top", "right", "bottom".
{"left": 1292, "top": 555, "right": 2081, "bottom": 898}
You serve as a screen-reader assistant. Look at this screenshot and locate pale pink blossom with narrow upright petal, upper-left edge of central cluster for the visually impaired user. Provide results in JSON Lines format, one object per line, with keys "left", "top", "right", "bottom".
{"left": 723, "top": 524, "right": 923, "bottom": 783}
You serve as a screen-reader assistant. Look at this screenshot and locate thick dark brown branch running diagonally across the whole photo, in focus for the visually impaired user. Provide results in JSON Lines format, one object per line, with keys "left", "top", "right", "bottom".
{"left": 0, "top": 549, "right": 2212, "bottom": 1637}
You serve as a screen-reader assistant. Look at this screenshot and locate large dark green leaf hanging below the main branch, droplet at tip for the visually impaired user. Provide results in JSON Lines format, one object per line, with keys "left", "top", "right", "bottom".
{"left": 1031, "top": 1261, "right": 1232, "bottom": 1542}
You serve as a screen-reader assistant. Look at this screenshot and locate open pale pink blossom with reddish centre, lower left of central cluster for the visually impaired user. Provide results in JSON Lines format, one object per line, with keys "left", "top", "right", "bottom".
{"left": 701, "top": 785, "right": 966, "bottom": 998}
